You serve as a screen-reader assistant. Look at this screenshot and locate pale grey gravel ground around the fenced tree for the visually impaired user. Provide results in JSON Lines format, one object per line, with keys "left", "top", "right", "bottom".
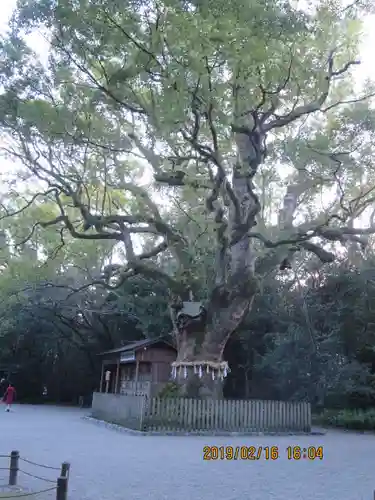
{"left": 0, "top": 405, "right": 375, "bottom": 500}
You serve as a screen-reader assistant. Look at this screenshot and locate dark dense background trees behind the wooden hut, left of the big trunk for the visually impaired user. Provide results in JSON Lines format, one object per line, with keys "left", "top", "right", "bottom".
{"left": 0, "top": 217, "right": 170, "bottom": 403}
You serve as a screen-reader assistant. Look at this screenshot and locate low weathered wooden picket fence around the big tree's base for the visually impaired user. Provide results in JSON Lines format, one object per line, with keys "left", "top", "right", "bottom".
{"left": 92, "top": 393, "right": 311, "bottom": 432}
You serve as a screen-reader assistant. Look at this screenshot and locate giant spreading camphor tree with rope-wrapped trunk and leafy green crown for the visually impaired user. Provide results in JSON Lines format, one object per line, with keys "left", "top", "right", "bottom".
{"left": 0, "top": 0, "right": 375, "bottom": 396}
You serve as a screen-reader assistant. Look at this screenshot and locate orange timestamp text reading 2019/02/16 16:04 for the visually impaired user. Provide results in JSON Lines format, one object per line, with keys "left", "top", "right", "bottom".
{"left": 203, "top": 446, "right": 324, "bottom": 461}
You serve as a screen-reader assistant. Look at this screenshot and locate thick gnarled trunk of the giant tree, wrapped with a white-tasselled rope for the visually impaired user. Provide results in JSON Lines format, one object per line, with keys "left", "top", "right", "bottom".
{"left": 174, "top": 130, "right": 264, "bottom": 398}
